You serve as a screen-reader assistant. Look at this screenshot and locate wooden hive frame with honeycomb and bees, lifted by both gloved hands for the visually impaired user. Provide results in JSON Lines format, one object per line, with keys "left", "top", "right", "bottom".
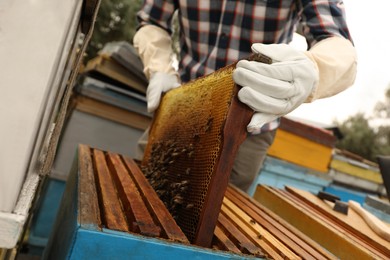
{"left": 142, "top": 62, "right": 253, "bottom": 247}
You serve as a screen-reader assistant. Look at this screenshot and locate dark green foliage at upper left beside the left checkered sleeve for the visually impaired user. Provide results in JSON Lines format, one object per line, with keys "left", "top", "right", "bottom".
{"left": 86, "top": 0, "right": 142, "bottom": 60}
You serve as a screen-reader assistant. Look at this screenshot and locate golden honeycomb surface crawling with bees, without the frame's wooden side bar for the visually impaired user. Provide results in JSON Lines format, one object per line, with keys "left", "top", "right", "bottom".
{"left": 142, "top": 61, "right": 251, "bottom": 246}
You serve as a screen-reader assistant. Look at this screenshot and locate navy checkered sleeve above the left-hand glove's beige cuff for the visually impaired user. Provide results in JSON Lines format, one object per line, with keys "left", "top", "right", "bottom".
{"left": 137, "top": 0, "right": 176, "bottom": 34}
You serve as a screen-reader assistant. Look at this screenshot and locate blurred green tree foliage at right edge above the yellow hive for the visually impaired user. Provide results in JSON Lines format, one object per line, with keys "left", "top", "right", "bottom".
{"left": 336, "top": 85, "right": 390, "bottom": 161}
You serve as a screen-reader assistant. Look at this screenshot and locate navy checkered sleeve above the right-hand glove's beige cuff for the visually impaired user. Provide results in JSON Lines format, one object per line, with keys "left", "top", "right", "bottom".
{"left": 301, "top": 0, "right": 352, "bottom": 47}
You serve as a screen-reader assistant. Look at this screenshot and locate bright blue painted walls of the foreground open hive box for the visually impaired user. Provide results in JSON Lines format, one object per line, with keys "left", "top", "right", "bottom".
{"left": 43, "top": 150, "right": 260, "bottom": 260}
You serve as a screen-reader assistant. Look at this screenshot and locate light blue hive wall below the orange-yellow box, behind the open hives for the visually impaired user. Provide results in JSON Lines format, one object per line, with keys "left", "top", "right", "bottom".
{"left": 248, "top": 156, "right": 331, "bottom": 196}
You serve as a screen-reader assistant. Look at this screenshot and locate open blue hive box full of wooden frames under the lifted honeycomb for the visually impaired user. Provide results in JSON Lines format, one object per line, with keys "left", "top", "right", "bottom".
{"left": 43, "top": 145, "right": 336, "bottom": 259}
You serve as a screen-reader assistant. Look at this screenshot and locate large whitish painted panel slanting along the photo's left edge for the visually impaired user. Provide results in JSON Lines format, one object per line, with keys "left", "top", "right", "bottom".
{"left": 0, "top": 0, "right": 82, "bottom": 212}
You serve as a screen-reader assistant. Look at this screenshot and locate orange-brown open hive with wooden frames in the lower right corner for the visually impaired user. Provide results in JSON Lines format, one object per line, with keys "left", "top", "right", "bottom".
{"left": 253, "top": 186, "right": 390, "bottom": 259}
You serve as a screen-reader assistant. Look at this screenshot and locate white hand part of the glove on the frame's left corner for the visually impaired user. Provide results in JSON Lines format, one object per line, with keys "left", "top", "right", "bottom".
{"left": 146, "top": 72, "right": 180, "bottom": 113}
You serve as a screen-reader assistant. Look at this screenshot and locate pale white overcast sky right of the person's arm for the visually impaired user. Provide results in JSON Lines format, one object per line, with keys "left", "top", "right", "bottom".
{"left": 289, "top": 0, "right": 390, "bottom": 125}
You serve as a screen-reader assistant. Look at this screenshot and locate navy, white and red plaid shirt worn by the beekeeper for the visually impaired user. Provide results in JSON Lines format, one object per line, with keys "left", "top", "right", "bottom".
{"left": 138, "top": 0, "right": 351, "bottom": 130}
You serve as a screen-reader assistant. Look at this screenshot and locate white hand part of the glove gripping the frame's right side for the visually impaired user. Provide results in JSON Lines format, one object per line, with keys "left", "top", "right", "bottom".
{"left": 233, "top": 43, "right": 319, "bottom": 134}
